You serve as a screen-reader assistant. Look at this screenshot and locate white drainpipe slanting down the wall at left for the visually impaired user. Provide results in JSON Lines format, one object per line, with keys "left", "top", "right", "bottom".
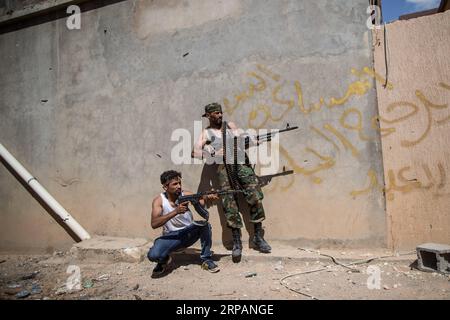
{"left": 0, "top": 143, "right": 91, "bottom": 240}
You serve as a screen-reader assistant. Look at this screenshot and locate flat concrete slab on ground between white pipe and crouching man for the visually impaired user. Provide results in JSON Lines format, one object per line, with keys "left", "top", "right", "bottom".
{"left": 70, "top": 236, "right": 150, "bottom": 263}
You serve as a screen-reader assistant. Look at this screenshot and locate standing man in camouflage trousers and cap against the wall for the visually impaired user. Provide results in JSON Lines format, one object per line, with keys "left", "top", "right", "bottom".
{"left": 192, "top": 103, "right": 272, "bottom": 262}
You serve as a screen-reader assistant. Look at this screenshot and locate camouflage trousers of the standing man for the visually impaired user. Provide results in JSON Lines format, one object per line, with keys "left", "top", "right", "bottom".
{"left": 217, "top": 164, "right": 266, "bottom": 228}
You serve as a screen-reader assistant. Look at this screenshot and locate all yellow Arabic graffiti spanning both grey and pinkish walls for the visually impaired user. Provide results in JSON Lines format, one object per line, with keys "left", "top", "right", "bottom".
{"left": 223, "top": 64, "right": 450, "bottom": 197}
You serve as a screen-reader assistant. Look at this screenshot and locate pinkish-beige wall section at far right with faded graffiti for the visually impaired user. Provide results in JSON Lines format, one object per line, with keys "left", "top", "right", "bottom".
{"left": 367, "top": 12, "right": 450, "bottom": 248}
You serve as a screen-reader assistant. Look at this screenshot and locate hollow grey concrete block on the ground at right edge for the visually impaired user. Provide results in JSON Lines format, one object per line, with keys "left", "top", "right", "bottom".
{"left": 416, "top": 243, "right": 450, "bottom": 274}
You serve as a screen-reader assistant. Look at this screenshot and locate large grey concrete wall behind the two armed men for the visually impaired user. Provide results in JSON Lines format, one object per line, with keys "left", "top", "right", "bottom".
{"left": 0, "top": 0, "right": 386, "bottom": 251}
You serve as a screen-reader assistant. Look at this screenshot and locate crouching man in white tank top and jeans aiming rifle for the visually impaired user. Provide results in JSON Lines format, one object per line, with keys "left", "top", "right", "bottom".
{"left": 147, "top": 170, "right": 219, "bottom": 277}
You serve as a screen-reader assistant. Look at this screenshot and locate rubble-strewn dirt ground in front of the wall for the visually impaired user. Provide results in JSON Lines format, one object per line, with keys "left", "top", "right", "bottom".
{"left": 0, "top": 245, "right": 450, "bottom": 300}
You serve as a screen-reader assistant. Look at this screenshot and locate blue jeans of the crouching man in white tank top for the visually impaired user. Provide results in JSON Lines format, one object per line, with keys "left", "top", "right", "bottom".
{"left": 147, "top": 223, "right": 212, "bottom": 262}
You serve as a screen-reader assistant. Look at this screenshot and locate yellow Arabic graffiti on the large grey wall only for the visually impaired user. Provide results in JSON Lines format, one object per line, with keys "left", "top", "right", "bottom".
{"left": 223, "top": 65, "right": 392, "bottom": 189}
